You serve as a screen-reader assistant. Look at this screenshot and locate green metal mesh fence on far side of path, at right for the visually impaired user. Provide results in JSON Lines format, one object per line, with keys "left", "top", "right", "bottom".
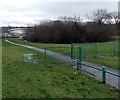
{"left": 71, "top": 42, "right": 118, "bottom": 58}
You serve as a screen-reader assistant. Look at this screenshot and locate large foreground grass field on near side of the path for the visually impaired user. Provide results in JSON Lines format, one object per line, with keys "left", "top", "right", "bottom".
{"left": 2, "top": 42, "right": 120, "bottom": 98}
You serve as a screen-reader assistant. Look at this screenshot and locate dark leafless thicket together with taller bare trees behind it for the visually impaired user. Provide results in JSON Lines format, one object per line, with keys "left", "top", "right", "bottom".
{"left": 26, "top": 9, "right": 120, "bottom": 44}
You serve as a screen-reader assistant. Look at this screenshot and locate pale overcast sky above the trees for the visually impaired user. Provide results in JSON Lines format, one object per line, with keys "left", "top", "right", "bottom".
{"left": 0, "top": 0, "right": 119, "bottom": 27}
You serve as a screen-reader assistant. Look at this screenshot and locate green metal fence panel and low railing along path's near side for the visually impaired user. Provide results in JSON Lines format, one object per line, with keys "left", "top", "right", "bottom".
{"left": 45, "top": 47, "right": 120, "bottom": 83}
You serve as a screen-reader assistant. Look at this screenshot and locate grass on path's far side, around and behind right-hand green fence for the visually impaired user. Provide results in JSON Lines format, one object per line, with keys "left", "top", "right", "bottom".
{"left": 74, "top": 40, "right": 120, "bottom": 69}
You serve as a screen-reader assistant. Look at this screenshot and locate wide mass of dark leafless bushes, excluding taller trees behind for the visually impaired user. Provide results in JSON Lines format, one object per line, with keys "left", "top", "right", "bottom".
{"left": 26, "top": 20, "right": 113, "bottom": 44}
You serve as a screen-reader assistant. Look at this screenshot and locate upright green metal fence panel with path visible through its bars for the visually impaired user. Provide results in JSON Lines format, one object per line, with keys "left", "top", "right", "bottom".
{"left": 45, "top": 47, "right": 82, "bottom": 68}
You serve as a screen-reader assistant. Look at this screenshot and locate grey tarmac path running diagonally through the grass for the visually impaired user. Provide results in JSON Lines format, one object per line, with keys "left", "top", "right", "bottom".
{"left": 5, "top": 40, "right": 120, "bottom": 88}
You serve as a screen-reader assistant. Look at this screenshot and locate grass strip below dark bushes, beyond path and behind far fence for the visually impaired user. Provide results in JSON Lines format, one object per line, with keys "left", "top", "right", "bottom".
{"left": 9, "top": 38, "right": 119, "bottom": 57}
